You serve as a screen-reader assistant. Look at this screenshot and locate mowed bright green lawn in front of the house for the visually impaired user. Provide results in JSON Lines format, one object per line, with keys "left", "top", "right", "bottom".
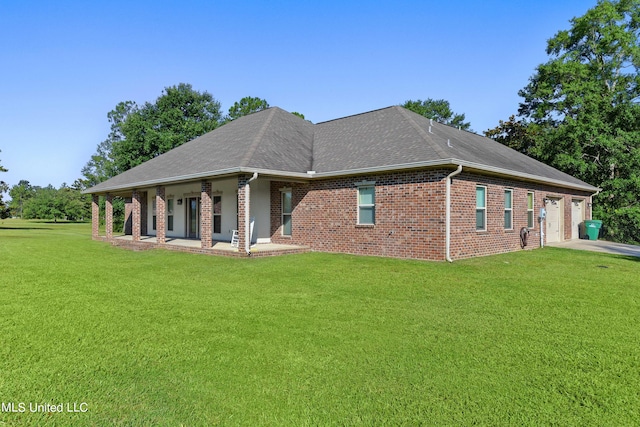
{"left": 0, "top": 220, "right": 640, "bottom": 426}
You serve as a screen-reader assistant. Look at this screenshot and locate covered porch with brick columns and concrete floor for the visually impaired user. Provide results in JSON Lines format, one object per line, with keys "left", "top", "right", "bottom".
{"left": 92, "top": 174, "right": 309, "bottom": 256}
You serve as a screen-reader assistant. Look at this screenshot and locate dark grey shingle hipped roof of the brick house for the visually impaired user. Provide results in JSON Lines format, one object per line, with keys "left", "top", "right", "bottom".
{"left": 87, "top": 106, "right": 597, "bottom": 193}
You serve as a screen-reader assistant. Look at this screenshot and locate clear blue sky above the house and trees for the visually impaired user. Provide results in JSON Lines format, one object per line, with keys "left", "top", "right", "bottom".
{"left": 0, "top": 0, "right": 596, "bottom": 191}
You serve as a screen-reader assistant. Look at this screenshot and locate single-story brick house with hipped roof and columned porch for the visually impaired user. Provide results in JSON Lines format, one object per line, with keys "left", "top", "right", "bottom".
{"left": 86, "top": 106, "right": 598, "bottom": 260}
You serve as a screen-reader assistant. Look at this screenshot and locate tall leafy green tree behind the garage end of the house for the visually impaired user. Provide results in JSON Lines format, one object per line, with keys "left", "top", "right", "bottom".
{"left": 496, "top": 0, "right": 640, "bottom": 242}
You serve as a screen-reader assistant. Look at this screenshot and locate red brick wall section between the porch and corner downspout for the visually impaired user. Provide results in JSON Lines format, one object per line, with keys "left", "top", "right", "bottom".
{"left": 271, "top": 170, "right": 450, "bottom": 260}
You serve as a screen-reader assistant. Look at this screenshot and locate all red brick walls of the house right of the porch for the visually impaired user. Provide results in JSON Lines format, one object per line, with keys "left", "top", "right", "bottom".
{"left": 271, "top": 170, "right": 591, "bottom": 260}
